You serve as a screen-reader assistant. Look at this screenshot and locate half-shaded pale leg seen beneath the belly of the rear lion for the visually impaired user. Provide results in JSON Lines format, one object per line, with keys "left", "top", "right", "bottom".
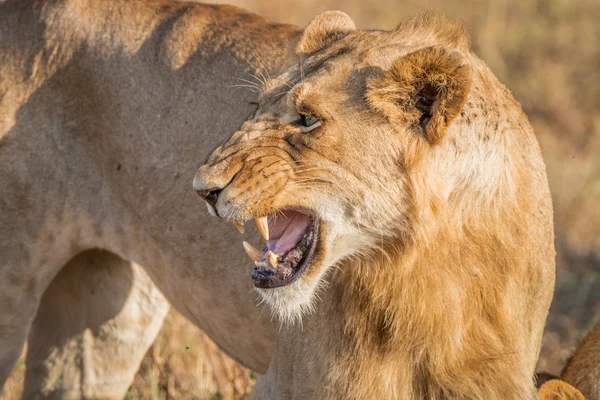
{"left": 23, "top": 250, "right": 169, "bottom": 399}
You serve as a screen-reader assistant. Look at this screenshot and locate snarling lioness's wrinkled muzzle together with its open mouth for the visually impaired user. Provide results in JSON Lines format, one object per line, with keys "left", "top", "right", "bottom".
{"left": 194, "top": 123, "right": 325, "bottom": 289}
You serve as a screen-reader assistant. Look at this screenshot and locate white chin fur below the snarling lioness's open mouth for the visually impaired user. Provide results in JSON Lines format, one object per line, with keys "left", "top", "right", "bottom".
{"left": 256, "top": 268, "right": 328, "bottom": 325}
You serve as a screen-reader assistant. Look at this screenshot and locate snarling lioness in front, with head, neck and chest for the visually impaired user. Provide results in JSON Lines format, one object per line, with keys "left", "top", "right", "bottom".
{"left": 194, "top": 12, "right": 555, "bottom": 399}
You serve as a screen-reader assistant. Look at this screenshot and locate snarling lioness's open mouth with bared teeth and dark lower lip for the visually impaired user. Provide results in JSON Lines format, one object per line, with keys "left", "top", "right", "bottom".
{"left": 236, "top": 210, "right": 319, "bottom": 289}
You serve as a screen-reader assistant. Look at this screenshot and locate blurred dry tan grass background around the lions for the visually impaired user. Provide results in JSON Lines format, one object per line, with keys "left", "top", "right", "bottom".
{"left": 4, "top": 0, "right": 600, "bottom": 400}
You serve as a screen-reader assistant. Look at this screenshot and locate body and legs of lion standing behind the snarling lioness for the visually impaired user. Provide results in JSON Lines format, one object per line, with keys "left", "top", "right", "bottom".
{"left": 0, "top": 0, "right": 296, "bottom": 398}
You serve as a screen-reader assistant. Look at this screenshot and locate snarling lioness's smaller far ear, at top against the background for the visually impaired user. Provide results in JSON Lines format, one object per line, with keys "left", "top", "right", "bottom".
{"left": 296, "top": 11, "right": 356, "bottom": 54}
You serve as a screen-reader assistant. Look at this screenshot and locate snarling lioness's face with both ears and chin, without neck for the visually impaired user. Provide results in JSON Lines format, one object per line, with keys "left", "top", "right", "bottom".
{"left": 194, "top": 13, "right": 470, "bottom": 318}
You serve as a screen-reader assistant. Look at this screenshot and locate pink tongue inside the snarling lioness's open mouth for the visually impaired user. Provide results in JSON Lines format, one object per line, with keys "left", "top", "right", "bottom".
{"left": 267, "top": 211, "right": 311, "bottom": 254}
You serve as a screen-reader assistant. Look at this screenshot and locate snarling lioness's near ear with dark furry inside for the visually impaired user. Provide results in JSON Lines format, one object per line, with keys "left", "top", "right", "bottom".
{"left": 367, "top": 47, "right": 472, "bottom": 144}
